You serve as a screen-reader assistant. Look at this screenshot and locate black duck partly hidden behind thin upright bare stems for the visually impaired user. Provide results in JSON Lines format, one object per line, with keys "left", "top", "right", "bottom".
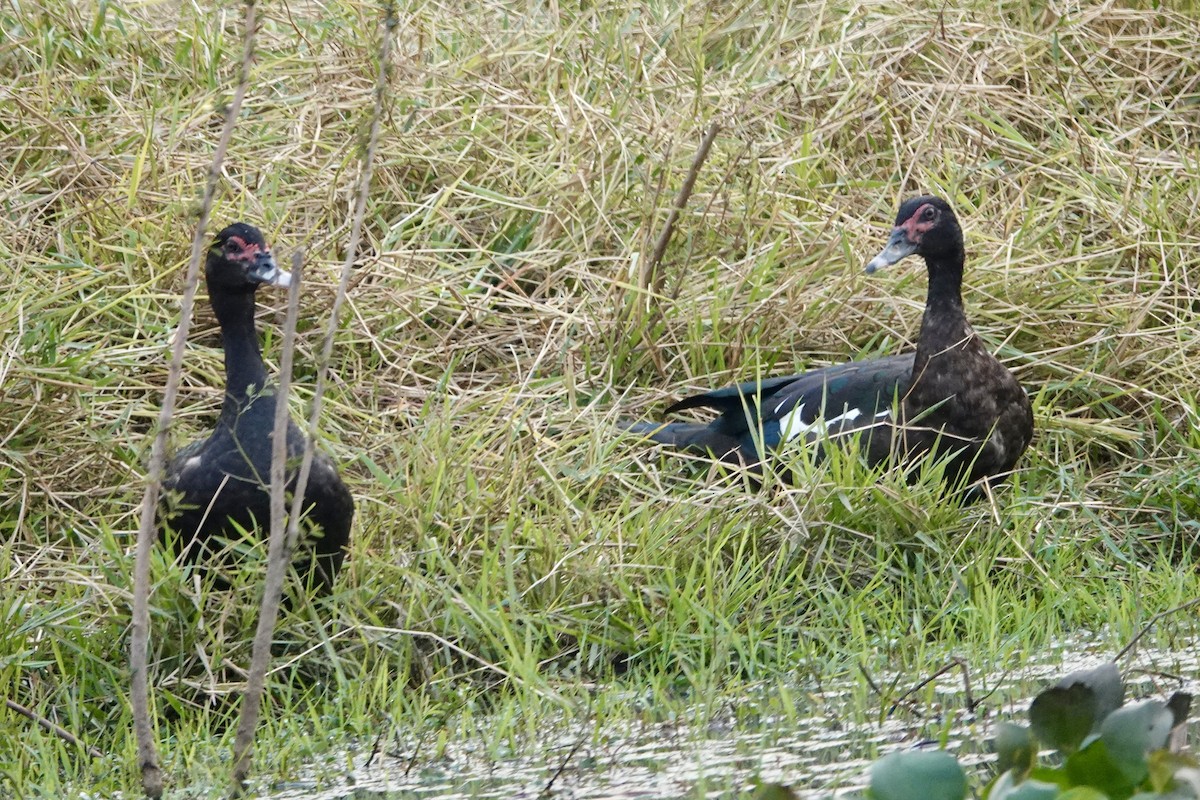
{"left": 161, "top": 223, "right": 354, "bottom": 594}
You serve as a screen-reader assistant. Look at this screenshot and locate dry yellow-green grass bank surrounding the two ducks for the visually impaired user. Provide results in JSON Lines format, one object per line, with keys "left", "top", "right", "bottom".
{"left": 0, "top": 0, "right": 1200, "bottom": 784}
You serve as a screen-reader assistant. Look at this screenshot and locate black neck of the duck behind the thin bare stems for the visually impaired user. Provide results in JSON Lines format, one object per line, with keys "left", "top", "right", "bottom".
{"left": 212, "top": 286, "right": 275, "bottom": 428}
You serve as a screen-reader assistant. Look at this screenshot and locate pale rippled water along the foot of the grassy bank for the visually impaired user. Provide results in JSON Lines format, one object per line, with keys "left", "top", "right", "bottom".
{"left": 269, "top": 637, "right": 1200, "bottom": 800}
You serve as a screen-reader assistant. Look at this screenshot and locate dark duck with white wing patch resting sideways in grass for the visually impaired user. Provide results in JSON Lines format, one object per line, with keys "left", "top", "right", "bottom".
{"left": 629, "top": 197, "right": 1033, "bottom": 494}
